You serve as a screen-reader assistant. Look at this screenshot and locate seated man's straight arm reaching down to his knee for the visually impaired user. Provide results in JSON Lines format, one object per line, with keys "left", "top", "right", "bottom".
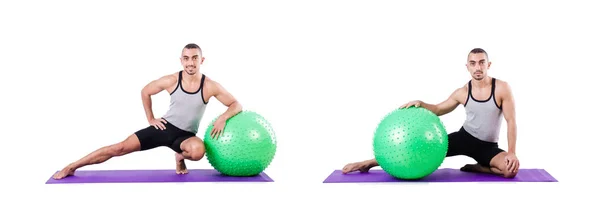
{"left": 499, "top": 82, "right": 517, "bottom": 154}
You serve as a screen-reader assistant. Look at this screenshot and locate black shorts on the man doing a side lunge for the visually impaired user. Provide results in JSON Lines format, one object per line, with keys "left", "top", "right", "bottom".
{"left": 135, "top": 119, "right": 196, "bottom": 153}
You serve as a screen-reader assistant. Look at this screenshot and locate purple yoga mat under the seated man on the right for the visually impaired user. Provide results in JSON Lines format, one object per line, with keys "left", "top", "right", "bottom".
{"left": 323, "top": 168, "right": 558, "bottom": 183}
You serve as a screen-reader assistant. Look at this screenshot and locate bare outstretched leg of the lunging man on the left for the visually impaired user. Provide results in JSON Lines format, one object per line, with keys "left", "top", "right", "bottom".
{"left": 53, "top": 134, "right": 140, "bottom": 179}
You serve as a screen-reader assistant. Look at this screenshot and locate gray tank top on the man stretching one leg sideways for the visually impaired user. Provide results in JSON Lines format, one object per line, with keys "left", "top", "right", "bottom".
{"left": 163, "top": 71, "right": 208, "bottom": 134}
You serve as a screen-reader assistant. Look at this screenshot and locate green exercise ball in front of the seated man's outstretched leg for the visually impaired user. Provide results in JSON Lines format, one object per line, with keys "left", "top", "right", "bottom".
{"left": 373, "top": 107, "right": 448, "bottom": 180}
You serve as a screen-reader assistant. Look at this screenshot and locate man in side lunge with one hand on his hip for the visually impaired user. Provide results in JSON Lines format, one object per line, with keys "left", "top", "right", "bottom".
{"left": 53, "top": 43, "right": 242, "bottom": 179}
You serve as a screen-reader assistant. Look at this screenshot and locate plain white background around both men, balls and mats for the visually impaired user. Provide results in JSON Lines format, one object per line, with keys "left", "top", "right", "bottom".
{"left": 0, "top": 1, "right": 600, "bottom": 208}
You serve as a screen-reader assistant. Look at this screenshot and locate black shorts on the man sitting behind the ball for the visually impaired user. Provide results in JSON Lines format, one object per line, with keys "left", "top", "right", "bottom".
{"left": 446, "top": 127, "right": 504, "bottom": 167}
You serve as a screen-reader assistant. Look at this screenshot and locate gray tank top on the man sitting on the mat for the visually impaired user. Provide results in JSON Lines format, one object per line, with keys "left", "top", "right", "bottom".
{"left": 463, "top": 78, "right": 502, "bottom": 143}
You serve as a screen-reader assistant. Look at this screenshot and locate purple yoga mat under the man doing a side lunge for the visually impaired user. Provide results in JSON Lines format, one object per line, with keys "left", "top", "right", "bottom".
{"left": 46, "top": 169, "right": 273, "bottom": 184}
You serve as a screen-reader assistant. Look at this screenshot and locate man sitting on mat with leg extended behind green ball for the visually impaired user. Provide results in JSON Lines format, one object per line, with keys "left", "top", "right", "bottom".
{"left": 342, "top": 48, "right": 519, "bottom": 178}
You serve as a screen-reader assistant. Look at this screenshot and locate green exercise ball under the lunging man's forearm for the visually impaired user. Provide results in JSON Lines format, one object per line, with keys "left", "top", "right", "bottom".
{"left": 204, "top": 111, "right": 277, "bottom": 176}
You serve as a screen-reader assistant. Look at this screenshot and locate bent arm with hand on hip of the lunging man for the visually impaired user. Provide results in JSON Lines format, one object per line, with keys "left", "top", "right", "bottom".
{"left": 141, "top": 75, "right": 177, "bottom": 122}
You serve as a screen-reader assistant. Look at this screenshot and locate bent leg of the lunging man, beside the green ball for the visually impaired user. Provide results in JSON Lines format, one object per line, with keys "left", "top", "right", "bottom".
{"left": 172, "top": 136, "right": 206, "bottom": 174}
